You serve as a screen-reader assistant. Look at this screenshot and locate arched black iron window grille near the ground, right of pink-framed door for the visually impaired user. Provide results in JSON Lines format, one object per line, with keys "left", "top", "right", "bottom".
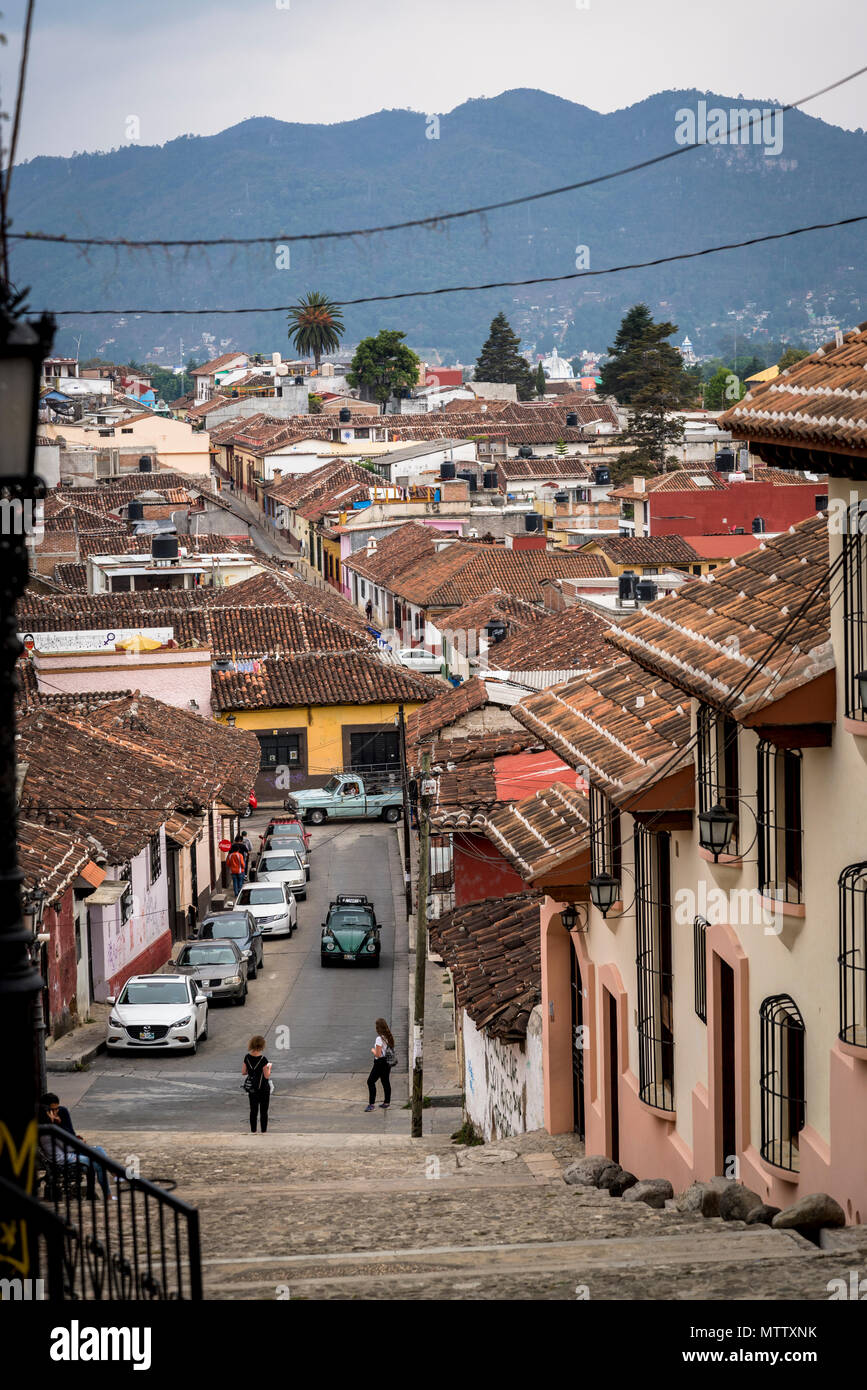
{"left": 759, "top": 994, "right": 807, "bottom": 1173}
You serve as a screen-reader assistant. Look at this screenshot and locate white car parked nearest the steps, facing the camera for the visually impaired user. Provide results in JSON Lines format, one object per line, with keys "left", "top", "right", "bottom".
{"left": 106, "top": 974, "right": 208, "bottom": 1052}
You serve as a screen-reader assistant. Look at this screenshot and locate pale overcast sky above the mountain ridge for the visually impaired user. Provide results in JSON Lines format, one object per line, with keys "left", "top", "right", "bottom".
{"left": 0, "top": 0, "right": 867, "bottom": 158}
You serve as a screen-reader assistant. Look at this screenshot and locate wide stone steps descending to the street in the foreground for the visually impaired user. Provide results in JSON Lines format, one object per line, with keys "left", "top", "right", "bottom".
{"left": 94, "top": 1131, "right": 867, "bottom": 1301}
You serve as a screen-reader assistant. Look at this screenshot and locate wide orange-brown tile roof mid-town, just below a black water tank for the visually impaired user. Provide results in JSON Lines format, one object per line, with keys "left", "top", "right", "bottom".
{"left": 393, "top": 541, "right": 610, "bottom": 607}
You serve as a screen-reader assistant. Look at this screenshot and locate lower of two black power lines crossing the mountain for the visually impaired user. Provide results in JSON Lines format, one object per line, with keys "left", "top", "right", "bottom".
{"left": 37, "top": 213, "right": 867, "bottom": 318}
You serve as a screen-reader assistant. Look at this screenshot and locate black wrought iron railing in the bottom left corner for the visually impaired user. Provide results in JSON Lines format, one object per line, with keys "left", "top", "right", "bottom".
{"left": 12, "top": 1125, "right": 201, "bottom": 1301}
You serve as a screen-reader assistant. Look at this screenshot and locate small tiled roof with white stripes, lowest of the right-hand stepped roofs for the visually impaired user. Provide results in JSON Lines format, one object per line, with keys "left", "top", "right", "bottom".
{"left": 485, "top": 783, "right": 591, "bottom": 880}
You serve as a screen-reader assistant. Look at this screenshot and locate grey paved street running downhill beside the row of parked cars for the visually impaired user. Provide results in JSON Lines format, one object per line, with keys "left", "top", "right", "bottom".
{"left": 63, "top": 810, "right": 453, "bottom": 1148}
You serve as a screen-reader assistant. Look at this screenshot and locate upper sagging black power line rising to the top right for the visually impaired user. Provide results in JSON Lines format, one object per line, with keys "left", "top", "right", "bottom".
{"left": 10, "top": 65, "right": 867, "bottom": 250}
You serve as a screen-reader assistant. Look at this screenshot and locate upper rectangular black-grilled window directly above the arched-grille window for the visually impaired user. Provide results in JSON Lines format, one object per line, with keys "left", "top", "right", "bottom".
{"left": 757, "top": 742, "right": 803, "bottom": 902}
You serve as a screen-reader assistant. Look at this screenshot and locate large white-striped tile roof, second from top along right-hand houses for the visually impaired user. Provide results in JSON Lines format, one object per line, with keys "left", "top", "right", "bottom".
{"left": 609, "top": 516, "right": 834, "bottom": 717}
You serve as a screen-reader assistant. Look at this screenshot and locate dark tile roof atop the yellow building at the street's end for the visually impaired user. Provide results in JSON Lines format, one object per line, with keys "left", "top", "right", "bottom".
{"left": 213, "top": 652, "right": 442, "bottom": 710}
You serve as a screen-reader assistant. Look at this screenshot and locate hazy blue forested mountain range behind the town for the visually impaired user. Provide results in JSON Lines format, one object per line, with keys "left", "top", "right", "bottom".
{"left": 11, "top": 89, "right": 867, "bottom": 361}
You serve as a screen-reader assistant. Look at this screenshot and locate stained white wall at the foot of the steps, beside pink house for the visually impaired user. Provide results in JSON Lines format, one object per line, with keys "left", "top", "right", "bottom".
{"left": 461, "top": 1006, "right": 543, "bottom": 1140}
